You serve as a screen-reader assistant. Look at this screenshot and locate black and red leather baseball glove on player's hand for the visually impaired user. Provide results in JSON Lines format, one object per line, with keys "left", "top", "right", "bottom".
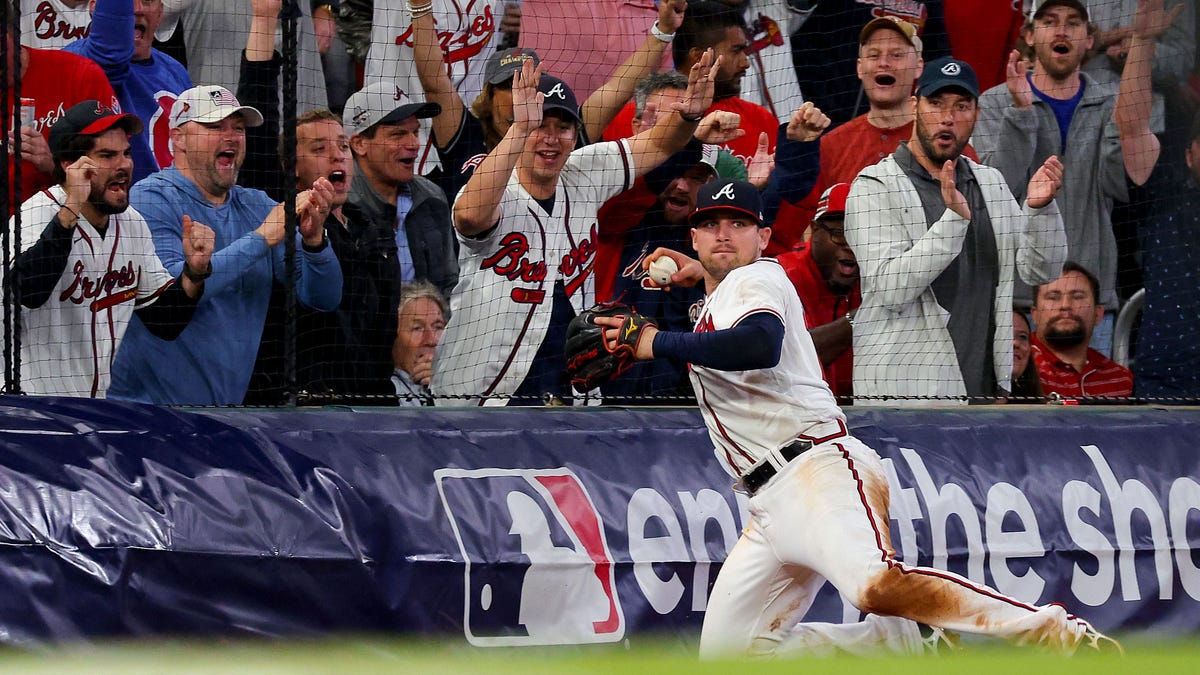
{"left": 565, "top": 303, "right": 655, "bottom": 392}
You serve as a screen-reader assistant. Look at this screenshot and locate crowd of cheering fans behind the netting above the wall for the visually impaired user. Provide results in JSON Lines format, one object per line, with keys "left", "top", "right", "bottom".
{"left": 0, "top": 0, "right": 1200, "bottom": 405}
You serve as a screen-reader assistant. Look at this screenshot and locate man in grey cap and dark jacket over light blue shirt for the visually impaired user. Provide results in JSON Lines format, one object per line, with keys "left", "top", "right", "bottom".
{"left": 342, "top": 83, "right": 458, "bottom": 294}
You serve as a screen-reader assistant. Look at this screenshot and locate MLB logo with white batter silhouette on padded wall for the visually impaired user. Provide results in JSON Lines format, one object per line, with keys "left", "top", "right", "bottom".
{"left": 434, "top": 468, "right": 625, "bottom": 646}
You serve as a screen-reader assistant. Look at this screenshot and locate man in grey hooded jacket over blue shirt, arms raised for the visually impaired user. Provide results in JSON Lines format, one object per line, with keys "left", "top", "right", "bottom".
{"left": 972, "top": 0, "right": 1177, "bottom": 354}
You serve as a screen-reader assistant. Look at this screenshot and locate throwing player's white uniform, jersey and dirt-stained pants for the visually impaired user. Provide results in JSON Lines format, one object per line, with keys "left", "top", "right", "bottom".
{"left": 691, "top": 258, "right": 1108, "bottom": 658}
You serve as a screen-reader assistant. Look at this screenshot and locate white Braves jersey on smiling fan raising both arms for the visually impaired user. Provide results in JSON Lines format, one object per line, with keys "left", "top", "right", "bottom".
{"left": 430, "top": 135, "right": 638, "bottom": 405}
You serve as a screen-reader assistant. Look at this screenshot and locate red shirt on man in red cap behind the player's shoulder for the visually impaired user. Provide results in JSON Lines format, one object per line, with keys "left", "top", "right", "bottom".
{"left": 775, "top": 244, "right": 863, "bottom": 398}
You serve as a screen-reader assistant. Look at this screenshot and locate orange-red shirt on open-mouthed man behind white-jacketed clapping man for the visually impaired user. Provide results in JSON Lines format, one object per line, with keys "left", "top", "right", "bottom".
{"left": 767, "top": 115, "right": 979, "bottom": 256}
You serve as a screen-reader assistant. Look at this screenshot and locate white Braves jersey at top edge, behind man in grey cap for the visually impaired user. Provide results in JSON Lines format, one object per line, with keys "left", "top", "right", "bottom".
{"left": 362, "top": 0, "right": 504, "bottom": 175}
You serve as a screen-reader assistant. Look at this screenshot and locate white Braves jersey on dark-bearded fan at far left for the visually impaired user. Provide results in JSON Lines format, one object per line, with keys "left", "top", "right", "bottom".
{"left": 9, "top": 185, "right": 174, "bottom": 398}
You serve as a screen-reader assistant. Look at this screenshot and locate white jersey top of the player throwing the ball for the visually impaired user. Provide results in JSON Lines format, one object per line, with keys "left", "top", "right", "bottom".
{"left": 691, "top": 258, "right": 845, "bottom": 478}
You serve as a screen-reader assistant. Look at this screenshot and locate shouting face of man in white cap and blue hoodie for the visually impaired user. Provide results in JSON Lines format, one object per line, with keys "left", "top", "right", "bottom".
{"left": 172, "top": 114, "right": 246, "bottom": 197}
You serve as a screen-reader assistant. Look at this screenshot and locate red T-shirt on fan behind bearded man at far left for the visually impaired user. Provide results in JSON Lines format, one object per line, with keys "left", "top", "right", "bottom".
{"left": 5, "top": 48, "right": 121, "bottom": 212}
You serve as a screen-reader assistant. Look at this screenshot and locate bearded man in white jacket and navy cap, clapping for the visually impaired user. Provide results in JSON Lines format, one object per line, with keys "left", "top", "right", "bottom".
{"left": 845, "top": 58, "right": 1067, "bottom": 405}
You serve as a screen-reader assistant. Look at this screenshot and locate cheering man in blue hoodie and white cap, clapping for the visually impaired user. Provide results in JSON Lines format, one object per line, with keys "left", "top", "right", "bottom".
{"left": 108, "top": 85, "right": 342, "bottom": 405}
